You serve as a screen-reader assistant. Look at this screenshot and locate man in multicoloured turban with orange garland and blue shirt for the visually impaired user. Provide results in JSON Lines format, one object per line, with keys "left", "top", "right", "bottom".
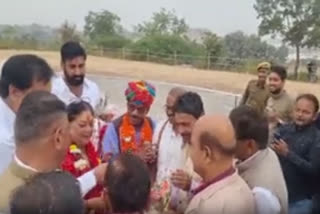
{"left": 103, "top": 81, "right": 156, "bottom": 163}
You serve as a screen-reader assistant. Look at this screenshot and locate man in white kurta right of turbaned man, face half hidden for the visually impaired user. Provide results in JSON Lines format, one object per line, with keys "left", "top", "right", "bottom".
{"left": 153, "top": 88, "right": 199, "bottom": 213}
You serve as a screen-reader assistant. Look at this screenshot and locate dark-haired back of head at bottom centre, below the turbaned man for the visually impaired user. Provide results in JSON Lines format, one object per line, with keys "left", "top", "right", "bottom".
{"left": 105, "top": 153, "right": 151, "bottom": 213}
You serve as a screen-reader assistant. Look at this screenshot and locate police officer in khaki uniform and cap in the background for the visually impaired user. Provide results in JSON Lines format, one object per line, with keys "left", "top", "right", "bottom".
{"left": 240, "top": 62, "right": 271, "bottom": 114}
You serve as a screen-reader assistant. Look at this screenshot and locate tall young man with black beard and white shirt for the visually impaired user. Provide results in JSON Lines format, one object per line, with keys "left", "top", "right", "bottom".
{"left": 51, "top": 42, "right": 100, "bottom": 109}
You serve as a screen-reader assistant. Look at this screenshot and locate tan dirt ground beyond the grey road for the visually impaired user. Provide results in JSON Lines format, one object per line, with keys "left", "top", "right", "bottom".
{"left": 0, "top": 50, "right": 320, "bottom": 97}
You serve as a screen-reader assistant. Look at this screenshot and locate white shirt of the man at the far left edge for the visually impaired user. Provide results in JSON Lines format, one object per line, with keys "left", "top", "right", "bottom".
{"left": 0, "top": 98, "right": 16, "bottom": 174}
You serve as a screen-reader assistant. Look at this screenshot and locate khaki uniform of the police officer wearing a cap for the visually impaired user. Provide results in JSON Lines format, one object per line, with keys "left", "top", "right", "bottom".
{"left": 240, "top": 80, "right": 269, "bottom": 114}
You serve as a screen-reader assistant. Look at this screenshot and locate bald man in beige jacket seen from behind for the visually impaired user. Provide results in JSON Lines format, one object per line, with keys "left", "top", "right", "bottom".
{"left": 186, "top": 116, "right": 255, "bottom": 214}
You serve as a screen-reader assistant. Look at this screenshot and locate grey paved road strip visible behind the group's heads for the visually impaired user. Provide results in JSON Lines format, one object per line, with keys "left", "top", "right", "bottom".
{"left": 89, "top": 75, "right": 239, "bottom": 120}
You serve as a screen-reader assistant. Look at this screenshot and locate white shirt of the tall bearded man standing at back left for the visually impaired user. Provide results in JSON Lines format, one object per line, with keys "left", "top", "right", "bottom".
{"left": 51, "top": 75, "right": 100, "bottom": 109}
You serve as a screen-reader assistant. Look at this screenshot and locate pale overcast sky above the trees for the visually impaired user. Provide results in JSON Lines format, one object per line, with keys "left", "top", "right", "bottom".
{"left": 0, "top": 0, "right": 258, "bottom": 35}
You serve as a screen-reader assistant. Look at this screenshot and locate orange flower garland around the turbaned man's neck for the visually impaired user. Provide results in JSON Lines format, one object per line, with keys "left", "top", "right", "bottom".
{"left": 119, "top": 114, "right": 152, "bottom": 153}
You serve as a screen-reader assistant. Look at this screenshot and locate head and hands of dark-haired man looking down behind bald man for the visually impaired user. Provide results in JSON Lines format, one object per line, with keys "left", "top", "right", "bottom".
{"left": 171, "top": 92, "right": 204, "bottom": 201}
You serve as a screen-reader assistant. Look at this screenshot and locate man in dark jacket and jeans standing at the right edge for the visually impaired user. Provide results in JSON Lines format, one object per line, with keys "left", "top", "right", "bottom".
{"left": 271, "top": 94, "right": 320, "bottom": 214}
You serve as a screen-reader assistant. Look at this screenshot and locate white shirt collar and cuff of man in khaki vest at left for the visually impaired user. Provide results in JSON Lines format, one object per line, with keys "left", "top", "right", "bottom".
{"left": 14, "top": 155, "right": 97, "bottom": 196}
